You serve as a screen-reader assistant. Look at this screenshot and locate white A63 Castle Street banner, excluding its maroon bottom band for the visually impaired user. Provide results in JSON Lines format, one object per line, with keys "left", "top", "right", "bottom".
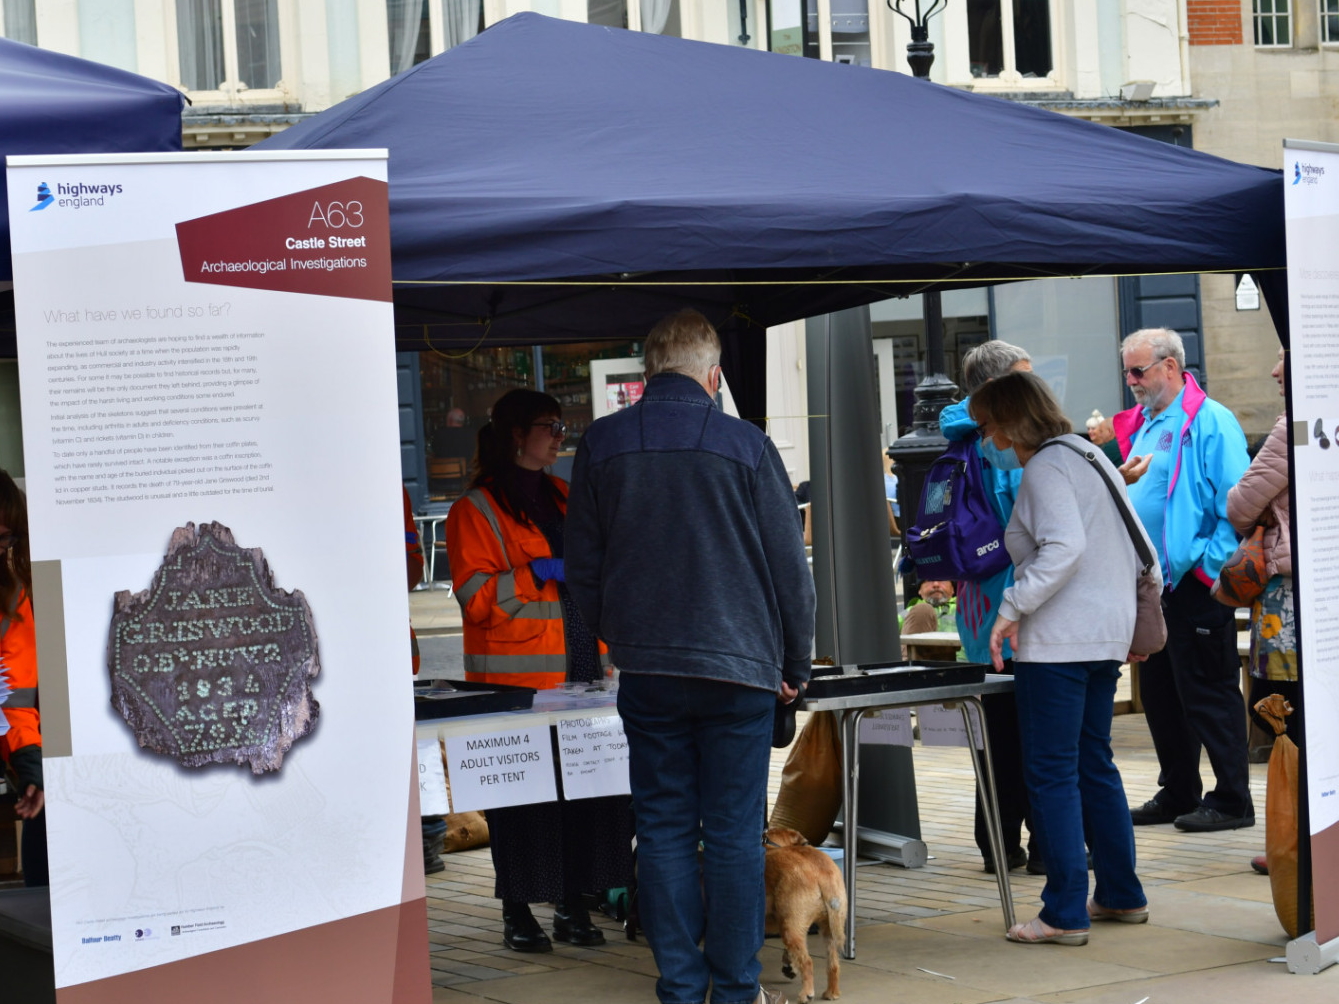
{"left": 8, "top": 151, "right": 412, "bottom": 987}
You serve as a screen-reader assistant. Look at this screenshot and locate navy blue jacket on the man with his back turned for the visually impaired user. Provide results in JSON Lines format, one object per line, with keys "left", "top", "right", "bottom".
{"left": 564, "top": 373, "right": 814, "bottom": 691}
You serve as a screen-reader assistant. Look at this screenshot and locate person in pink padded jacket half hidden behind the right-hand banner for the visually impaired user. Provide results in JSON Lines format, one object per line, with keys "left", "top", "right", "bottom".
{"left": 1228, "top": 348, "right": 1299, "bottom": 873}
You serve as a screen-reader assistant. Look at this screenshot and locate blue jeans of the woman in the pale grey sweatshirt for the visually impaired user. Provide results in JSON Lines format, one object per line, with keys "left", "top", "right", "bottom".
{"left": 1014, "top": 660, "right": 1148, "bottom": 930}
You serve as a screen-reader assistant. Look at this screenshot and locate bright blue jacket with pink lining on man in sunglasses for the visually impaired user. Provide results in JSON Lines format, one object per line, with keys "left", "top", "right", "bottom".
{"left": 1111, "top": 373, "right": 1251, "bottom": 589}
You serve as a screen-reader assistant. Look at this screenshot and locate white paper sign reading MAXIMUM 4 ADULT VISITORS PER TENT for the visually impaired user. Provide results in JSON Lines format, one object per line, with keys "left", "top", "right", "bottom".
{"left": 446, "top": 726, "right": 558, "bottom": 813}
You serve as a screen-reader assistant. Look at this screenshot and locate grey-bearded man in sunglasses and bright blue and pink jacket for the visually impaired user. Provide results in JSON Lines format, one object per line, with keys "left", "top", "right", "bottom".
{"left": 1111, "top": 328, "right": 1255, "bottom": 831}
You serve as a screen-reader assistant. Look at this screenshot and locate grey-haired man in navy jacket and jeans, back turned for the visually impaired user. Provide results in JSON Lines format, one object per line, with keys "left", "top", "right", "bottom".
{"left": 565, "top": 311, "right": 814, "bottom": 1004}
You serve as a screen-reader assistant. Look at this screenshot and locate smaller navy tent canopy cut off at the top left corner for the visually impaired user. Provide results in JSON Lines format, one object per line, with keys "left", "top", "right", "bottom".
{"left": 0, "top": 39, "right": 185, "bottom": 282}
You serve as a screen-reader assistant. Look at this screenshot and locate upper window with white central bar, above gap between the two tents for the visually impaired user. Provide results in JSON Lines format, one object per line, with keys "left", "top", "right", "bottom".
{"left": 177, "top": 0, "right": 281, "bottom": 91}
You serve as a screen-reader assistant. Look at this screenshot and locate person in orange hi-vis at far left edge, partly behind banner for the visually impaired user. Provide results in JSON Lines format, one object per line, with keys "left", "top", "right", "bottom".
{"left": 0, "top": 471, "right": 47, "bottom": 886}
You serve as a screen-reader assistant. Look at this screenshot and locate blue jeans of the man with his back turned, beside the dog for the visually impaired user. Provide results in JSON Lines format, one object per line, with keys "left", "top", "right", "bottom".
{"left": 619, "top": 672, "right": 777, "bottom": 1004}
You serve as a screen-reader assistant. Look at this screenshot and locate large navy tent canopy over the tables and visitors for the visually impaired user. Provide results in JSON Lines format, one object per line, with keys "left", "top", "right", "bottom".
{"left": 260, "top": 13, "right": 1284, "bottom": 348}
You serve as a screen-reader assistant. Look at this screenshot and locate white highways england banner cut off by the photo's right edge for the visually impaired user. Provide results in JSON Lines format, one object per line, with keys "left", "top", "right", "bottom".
{"left": 1280, "top": 141, "right": 1339, "bottom": 944}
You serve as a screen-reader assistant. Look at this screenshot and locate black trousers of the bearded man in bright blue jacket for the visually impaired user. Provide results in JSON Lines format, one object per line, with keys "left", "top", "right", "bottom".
{"left": 1139, "top": 574, "right": 1253, "bottom": 815}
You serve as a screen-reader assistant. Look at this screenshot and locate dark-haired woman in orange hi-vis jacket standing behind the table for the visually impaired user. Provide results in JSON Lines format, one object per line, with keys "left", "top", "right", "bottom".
{"left": 446, "top": 390, "right": 632, "bottom": 952}
